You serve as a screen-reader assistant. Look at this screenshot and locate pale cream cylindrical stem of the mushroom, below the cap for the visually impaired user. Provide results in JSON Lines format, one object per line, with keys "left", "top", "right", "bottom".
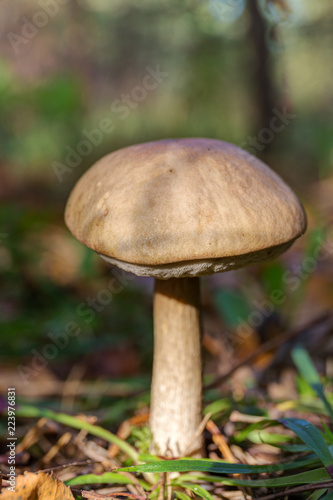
{"left": 150, "top": 278, "right": 202, "bottom": 457}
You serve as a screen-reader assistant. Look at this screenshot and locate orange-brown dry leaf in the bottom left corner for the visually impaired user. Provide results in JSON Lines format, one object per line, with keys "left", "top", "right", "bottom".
{"left": 0, "top": 472, "right": 74, "bottom": 500}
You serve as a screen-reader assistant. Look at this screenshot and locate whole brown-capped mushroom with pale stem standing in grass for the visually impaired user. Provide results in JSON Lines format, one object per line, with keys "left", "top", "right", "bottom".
{"left": 65, "top": 138, "right": 306, "bottom": 457}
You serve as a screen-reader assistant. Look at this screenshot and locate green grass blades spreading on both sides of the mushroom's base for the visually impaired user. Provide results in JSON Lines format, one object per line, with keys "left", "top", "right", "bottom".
{"left": 12, "top": 346, "right": 333, "bottom": 500}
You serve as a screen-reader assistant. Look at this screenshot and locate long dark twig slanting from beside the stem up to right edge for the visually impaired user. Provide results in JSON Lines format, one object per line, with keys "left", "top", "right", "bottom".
{"left": 204, "top": 311, "right": 333, "bottom": 390}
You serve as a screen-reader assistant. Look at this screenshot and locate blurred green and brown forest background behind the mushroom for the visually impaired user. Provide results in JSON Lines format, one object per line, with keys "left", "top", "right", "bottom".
{"left": 0, "top": 0, "right": 333, "bottom": 422}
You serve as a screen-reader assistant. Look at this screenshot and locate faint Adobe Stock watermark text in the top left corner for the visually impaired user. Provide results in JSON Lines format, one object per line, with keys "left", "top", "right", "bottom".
{"left": 7, "top": 0, "right": 70, "bottom": 54}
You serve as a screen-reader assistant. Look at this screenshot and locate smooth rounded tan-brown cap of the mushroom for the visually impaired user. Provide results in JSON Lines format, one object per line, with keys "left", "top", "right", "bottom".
{"left": 65, "top": 138, "right": 306, "bottom": 279}
